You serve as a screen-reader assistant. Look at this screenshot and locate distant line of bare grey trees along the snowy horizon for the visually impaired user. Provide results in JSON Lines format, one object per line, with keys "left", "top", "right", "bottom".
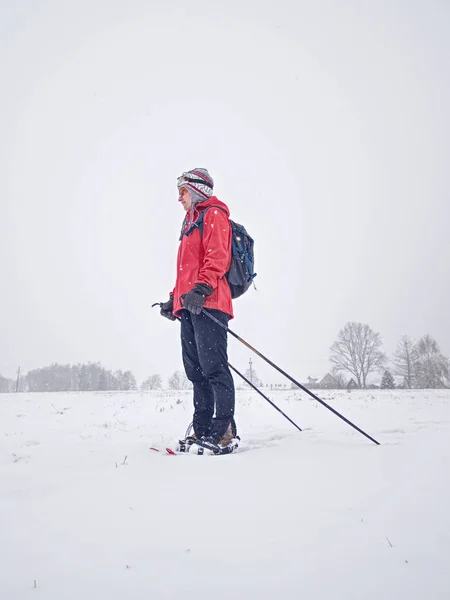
{"left": 0, "top": 322, "right": 450, "bottom": 392}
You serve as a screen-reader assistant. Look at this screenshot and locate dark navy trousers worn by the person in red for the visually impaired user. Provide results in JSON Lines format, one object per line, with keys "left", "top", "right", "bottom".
{"left": 181, "top": 309, "right": 236, "bottom": 441}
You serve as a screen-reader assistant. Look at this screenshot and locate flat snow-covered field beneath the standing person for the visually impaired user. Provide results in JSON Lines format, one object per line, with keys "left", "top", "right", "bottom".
{"left": 0, "top": 391, "right": 450, "bottom": 600}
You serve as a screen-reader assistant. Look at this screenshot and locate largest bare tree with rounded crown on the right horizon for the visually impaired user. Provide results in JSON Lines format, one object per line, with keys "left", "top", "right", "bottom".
{"left": 330, "top": 322, "right": 386, "bottom": 388}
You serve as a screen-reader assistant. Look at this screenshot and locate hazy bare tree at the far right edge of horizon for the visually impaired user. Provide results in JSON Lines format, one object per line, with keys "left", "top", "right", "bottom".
{"left": 416, "top": 335, "right": 450, "bottom": 388}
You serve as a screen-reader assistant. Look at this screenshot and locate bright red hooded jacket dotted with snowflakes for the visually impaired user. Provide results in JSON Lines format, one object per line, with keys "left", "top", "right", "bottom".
{"left": 172, "top": 196, "right": 233, "bottom": 317}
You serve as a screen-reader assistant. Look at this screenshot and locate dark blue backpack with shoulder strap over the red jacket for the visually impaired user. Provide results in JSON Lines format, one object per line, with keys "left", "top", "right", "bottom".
{"left": 184, "top": 206, "right": 256, "bottom": 300}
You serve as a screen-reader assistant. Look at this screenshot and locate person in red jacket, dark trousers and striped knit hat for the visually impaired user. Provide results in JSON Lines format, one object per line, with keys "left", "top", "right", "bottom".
{"left": 161, "top": 168, "right": 239, "bottom": 453}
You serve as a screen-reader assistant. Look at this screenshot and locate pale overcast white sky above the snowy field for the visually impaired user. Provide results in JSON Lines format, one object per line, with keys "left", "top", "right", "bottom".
{"left": 0, "top": 0, "right": 450, "bottom": 383}
